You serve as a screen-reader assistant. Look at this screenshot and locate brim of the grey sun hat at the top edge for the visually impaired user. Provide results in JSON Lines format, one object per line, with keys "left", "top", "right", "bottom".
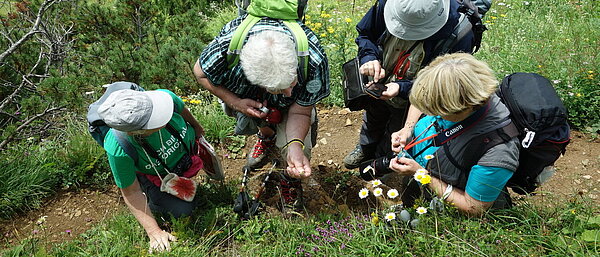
{"left": 383, "top": 0, "right": 450, "bottom": 40}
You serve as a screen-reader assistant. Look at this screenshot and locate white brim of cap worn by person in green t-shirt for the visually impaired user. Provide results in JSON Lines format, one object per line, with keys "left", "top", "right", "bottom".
{"left": 142, "top": 90, "right": 174, "bottom": 129}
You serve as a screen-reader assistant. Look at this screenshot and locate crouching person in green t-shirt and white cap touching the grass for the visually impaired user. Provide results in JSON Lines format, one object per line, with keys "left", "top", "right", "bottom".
{"left": 98, "top": 89, "right": 204, "bottom": 251}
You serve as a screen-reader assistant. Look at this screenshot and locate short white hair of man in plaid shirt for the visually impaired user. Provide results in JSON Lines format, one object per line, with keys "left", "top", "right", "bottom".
{"left": 240, "top": 30, "right": 298, "bottom": 91}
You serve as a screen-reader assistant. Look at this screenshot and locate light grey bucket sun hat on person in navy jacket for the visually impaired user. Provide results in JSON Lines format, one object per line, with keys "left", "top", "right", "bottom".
{"left": 383, "top": 0, "right": 451, "bottom": 40}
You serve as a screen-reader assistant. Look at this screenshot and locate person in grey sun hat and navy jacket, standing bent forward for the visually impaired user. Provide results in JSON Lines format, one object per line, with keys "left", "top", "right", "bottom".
{"left": 344, "top": 0, "right": 473, "bottom": 169}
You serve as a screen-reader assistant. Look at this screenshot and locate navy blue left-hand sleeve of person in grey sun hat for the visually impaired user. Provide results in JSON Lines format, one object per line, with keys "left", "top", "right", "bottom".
{"left": 355, "top": 0, "right": 386, "bottom": 65}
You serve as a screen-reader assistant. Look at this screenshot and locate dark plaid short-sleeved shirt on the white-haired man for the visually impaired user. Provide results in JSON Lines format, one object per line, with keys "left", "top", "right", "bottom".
{"left": 199, "top": 16, "right": 330, "bottom": 108}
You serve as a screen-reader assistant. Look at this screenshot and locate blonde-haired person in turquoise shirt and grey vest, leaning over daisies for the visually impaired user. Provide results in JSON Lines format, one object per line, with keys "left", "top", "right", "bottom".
{"left": 390, "top": 53, "right": 519, "bottom": 216}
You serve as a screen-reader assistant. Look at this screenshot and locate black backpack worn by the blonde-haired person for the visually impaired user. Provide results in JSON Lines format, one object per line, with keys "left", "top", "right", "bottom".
{"left": 457, "top": 73, "right": 570, "bottom": 194}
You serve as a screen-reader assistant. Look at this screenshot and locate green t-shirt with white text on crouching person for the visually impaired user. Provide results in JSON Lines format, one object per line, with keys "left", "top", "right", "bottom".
{"left": 104, "top": 89, "right": 196, "bottom": 188}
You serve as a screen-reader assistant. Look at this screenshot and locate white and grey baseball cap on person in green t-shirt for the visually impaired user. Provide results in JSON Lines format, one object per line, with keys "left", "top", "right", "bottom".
{"left": 98, "top": 89, "right": 174, "bottom": 132}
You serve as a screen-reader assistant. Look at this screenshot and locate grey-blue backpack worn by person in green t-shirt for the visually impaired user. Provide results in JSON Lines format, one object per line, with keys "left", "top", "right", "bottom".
{"left": 87, "top": 81, "right": 144, "bottom": 165}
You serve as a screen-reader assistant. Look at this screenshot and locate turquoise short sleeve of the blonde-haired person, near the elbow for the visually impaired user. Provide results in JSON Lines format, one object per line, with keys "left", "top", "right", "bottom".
{"left": 465, "top": 165, "right": 513, "bottom": 202}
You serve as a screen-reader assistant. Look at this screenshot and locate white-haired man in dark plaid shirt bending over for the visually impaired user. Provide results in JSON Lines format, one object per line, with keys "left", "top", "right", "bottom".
{"left": 193, "top": 16, "right": 330, "bottom": 209}
